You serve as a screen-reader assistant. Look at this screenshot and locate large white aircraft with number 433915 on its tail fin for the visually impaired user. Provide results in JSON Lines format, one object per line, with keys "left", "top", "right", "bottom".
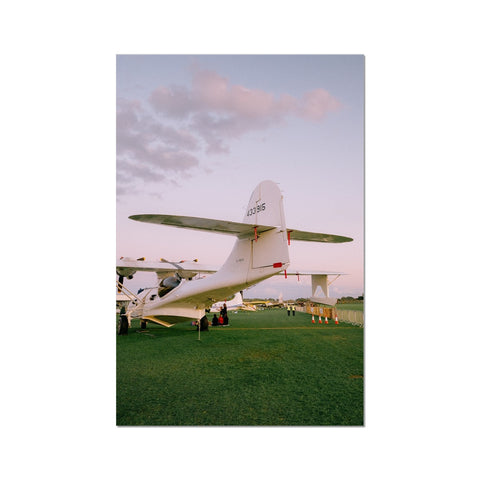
{"left": 117, "top": 180, "right": 353, "bottom": 327}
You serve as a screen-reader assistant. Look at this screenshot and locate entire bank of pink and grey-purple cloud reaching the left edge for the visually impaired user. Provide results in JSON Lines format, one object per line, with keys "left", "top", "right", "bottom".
{"left": 117, "top": 68, "right": 341, "bottom": 195}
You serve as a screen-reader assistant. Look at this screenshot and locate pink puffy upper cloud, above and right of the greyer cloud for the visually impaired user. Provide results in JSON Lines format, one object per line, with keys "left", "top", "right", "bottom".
{"left": 149, "top": 69, "right": 340, "bottom": 153}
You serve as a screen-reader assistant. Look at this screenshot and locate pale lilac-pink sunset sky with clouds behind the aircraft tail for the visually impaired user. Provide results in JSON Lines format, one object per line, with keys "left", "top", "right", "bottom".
{"left": 117, "top": 55, "right": 364, "bottom": 298}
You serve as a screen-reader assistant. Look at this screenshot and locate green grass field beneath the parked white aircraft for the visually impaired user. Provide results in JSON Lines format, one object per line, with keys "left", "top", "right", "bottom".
{"left": 117, "top": 310, "right": 363, "bottom": 425}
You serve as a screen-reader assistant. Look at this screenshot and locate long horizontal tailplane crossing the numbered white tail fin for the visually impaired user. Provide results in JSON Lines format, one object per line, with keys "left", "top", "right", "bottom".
{"left": 128, "top": 214, "right": 353, "bottom": 243}
